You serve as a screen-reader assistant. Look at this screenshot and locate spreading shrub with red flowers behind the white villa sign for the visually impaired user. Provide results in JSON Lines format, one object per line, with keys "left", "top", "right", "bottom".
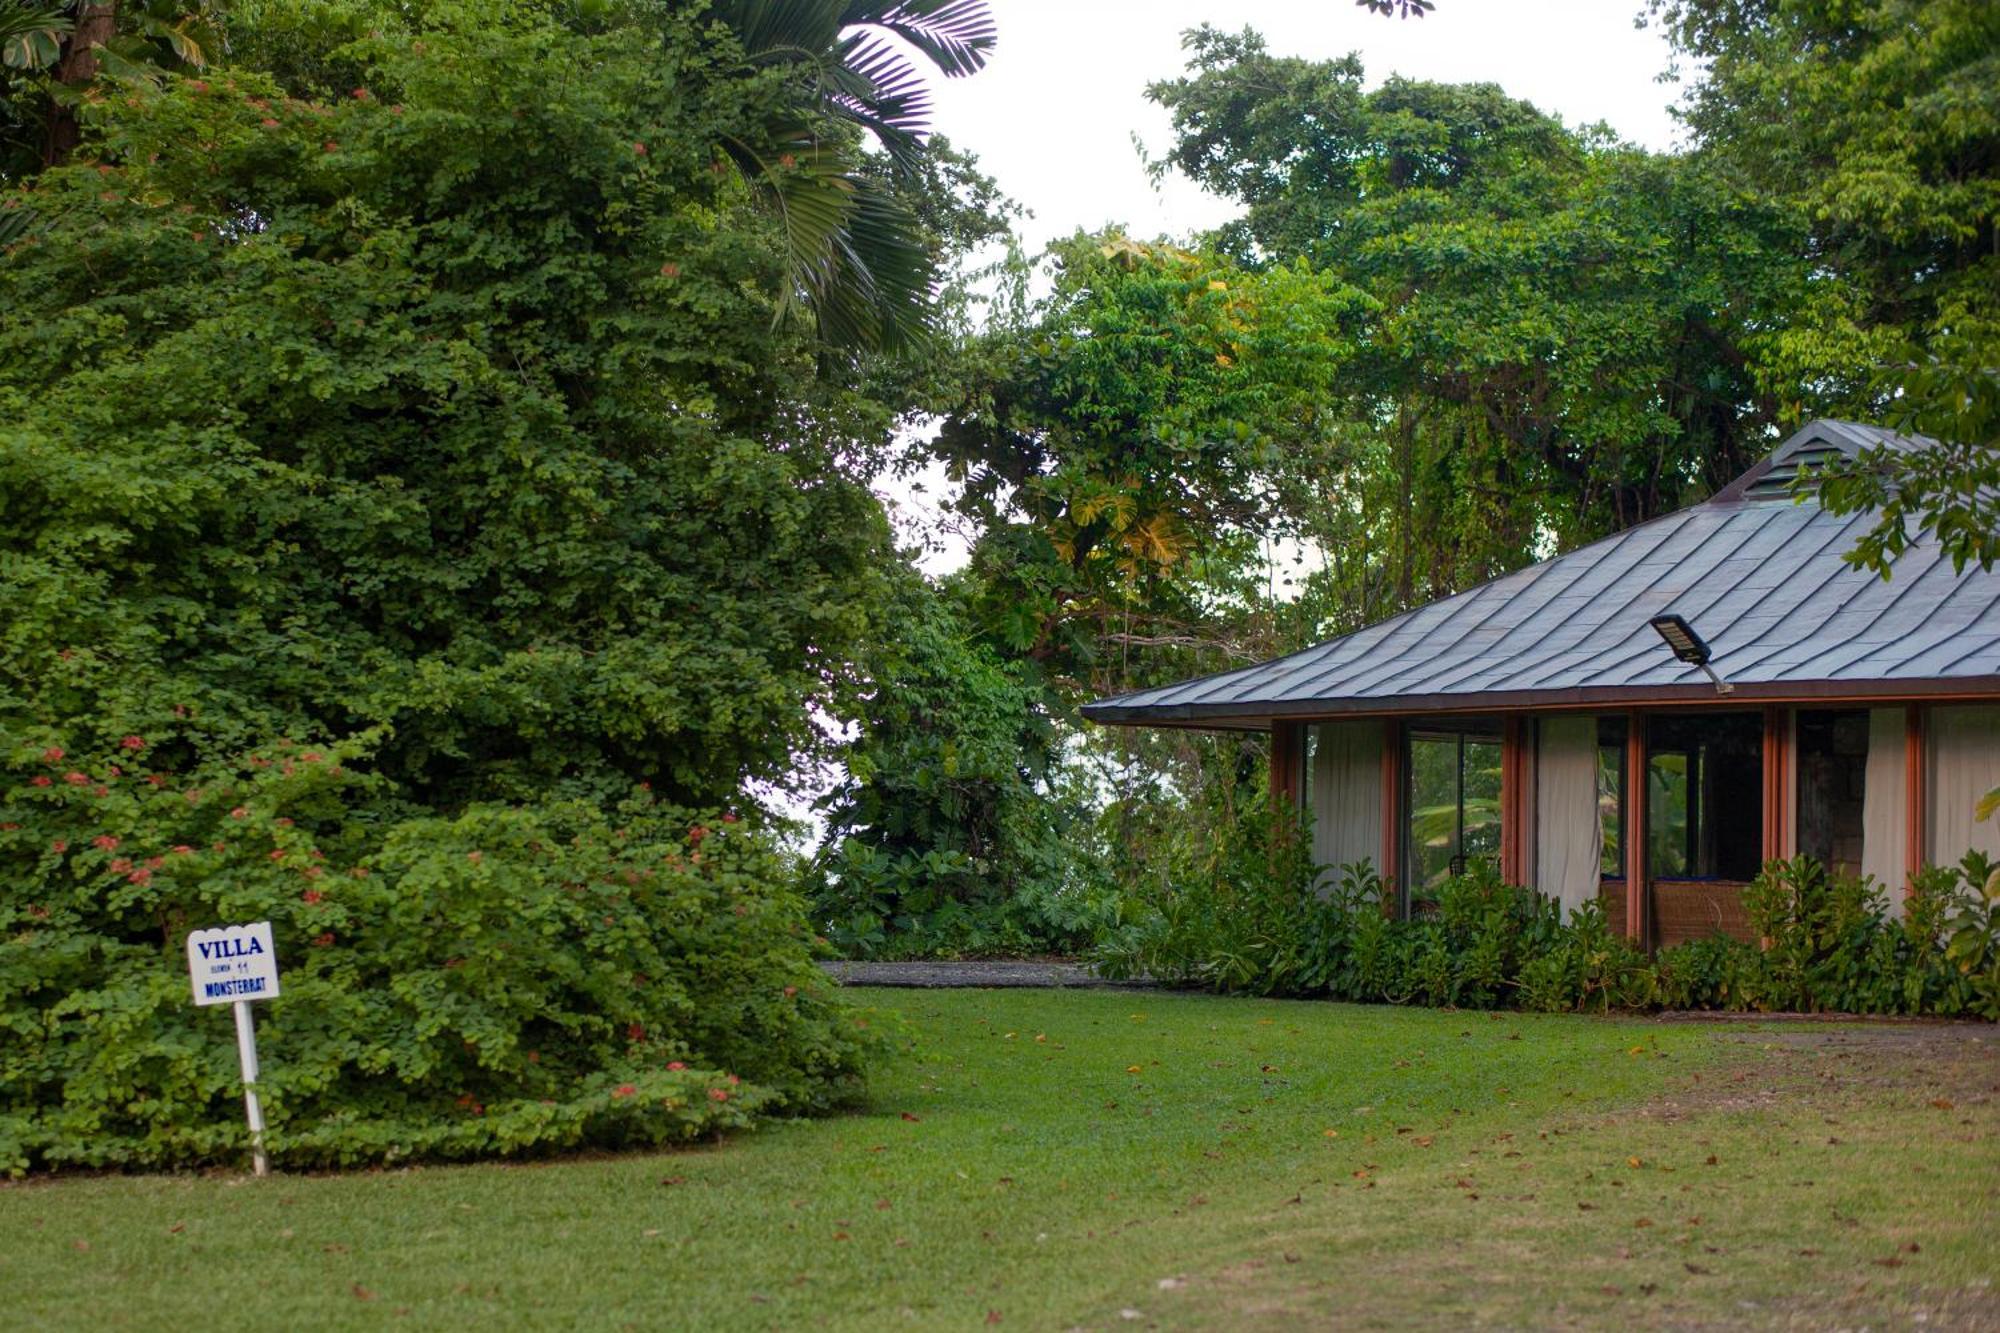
{"left": 0, "top": 737, "right": 872, "bottom": 1173}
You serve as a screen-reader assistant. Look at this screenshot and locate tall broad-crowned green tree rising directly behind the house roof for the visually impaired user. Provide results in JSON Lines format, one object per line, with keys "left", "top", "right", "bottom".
{"left": 1150, "top": 28, "right": 1804, "bottom": 608}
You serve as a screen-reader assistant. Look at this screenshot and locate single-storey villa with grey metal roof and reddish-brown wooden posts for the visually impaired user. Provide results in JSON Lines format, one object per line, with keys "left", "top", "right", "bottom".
{"left": 1084, "top": 420, "right": 2000, "bottom": 947}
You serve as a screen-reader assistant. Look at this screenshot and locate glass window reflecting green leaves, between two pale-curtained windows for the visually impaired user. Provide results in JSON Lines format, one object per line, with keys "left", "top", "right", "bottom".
{"left": 1408, "top": 723, "right": 1500, "bottom": 891}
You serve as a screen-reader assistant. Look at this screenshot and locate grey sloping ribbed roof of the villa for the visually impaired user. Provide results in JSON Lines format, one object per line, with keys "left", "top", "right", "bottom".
{"left": 1082, "top": 420, "right": 2000, "bottom": 727}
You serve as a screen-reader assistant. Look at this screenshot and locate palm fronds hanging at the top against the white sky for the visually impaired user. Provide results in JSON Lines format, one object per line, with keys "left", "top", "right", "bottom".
{"left": 712, "top": 0, "right": 994, "bottom": 348}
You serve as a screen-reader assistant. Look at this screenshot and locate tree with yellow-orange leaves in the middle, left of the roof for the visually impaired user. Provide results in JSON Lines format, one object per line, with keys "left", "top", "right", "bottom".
{"left": 930, "top": 234, "right": 1368, "bottom": 685}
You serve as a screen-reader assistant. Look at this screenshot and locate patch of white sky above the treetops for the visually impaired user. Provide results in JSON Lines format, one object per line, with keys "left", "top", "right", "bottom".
{"left": 932, "top": 0, "right": 1674, "bottom": 252}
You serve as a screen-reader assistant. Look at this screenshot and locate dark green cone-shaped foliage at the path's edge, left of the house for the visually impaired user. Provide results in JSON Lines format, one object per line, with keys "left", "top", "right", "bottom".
{"left": 814, "top": 576, "right": 1110, "bottom": 957}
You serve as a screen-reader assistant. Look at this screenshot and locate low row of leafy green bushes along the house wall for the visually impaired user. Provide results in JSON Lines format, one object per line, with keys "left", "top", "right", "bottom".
{"left": 1098, "top": 792, "right": 2000, "bottom": 1019}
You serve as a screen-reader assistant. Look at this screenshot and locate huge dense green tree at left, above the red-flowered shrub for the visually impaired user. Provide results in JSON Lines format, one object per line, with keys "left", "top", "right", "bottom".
{"left": 0, "top": 8, "right": 888, "bottom": 807}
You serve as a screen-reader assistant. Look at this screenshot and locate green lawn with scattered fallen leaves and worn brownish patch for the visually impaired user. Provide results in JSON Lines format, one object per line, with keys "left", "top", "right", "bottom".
{"left": 0, "top": 991, "right": 2000, "bottom": 1329}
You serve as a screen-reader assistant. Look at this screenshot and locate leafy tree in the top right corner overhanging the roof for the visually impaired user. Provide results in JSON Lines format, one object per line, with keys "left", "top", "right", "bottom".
{"left": 1648, "top": 0, "right": 2000, "bottom": 574}
